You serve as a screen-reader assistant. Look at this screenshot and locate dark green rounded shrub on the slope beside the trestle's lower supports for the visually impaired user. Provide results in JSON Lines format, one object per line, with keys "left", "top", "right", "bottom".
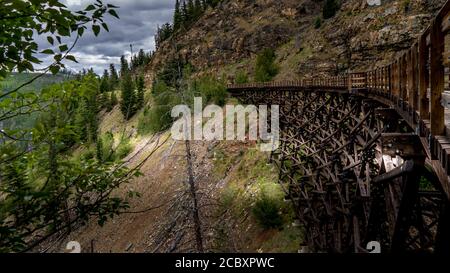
{"left": 253, "top": 192, "right": 283, "bottom": 229}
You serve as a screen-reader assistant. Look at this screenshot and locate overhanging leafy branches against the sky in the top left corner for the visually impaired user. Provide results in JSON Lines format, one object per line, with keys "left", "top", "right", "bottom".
{"left": 0, "top": 0, "right": 118, "bottom": 78}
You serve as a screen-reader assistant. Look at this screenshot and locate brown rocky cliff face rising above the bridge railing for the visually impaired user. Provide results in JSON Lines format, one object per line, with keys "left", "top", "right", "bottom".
{"left": 147, "top": 0, "right": 445, "bottom": 80}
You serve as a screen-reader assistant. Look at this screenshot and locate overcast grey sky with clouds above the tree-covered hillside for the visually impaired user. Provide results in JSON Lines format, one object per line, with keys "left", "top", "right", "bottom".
{"left": 37, "top": 0, "right": 175, "bottom": 74}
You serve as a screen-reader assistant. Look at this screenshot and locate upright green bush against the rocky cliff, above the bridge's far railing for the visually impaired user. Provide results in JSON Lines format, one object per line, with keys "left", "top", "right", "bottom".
{"left": 255, "top": 48, "right": 278, "bottom": 82}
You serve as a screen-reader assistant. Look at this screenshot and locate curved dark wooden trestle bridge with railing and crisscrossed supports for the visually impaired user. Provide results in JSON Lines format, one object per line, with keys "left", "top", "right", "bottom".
{"left": 228, "top": 1, "right": 450, "bottom": 253}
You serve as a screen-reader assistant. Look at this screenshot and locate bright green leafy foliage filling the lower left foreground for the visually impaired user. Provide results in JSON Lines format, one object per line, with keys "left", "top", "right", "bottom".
{"left": 0, "top": 77, "right": 138, "bottom": 252}
